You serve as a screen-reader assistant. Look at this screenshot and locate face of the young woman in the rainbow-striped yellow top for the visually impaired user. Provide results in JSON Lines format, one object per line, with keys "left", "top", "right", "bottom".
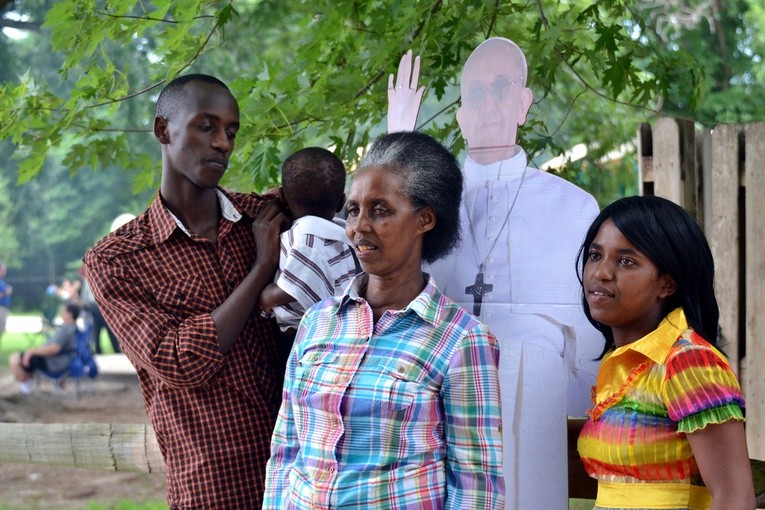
{"left": 583, "top": 219, "right": 675, "bottom": 347}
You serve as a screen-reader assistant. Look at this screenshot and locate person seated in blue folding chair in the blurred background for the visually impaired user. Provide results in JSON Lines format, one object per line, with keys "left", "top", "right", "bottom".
{"left": 9, "top": 303, "right": 80, "bottom": 394}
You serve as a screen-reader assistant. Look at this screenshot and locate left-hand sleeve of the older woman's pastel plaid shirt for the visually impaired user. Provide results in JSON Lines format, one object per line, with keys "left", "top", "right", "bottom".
{"left": 263, "top": 328, "right": 302, "bottom": 510}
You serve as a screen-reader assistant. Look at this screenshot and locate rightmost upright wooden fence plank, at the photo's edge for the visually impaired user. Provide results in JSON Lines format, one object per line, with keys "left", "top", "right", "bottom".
{"left": 744, "top": 123, "right": 765, "bottom": 459}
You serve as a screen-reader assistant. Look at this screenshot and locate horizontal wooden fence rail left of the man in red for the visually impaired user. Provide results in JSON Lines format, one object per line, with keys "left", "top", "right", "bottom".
{"left": 0, "top": 423, "right": 165, "bottom": 473}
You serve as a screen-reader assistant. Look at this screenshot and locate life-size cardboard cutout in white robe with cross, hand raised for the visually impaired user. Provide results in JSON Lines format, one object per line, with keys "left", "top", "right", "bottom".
{"left": 388, "top": 37, "right": 603, "bottom": 510}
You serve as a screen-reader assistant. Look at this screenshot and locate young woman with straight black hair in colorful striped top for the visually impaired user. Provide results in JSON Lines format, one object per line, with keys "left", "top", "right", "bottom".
{"left": 578, "top": 197, "right": 755, "bottom": 510}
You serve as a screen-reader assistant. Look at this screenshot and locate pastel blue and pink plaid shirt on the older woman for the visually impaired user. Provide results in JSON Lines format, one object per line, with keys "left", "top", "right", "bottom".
{"left": 263, "top": 274, "right": 504, "bottom": 510}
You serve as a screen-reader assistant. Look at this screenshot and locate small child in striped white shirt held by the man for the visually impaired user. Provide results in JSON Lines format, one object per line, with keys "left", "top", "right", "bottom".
{"left": 259, "top": 147, "right": 357, "bottom": 349}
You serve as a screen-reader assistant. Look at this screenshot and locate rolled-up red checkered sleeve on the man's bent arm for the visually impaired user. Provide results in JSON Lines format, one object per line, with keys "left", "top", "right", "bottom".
{"left": 85, "top": 247, "right": 223, "bottom": 388}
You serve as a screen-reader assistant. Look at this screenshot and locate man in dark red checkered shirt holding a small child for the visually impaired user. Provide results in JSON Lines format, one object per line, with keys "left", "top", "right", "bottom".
{"left": 84, "top": 75, "right": 287, "bottom": 509}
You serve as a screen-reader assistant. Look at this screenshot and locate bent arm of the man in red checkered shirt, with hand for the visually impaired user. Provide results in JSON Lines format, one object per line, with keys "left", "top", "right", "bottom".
{"left": 85, "top": 201, "right": 286, "bottom": 387}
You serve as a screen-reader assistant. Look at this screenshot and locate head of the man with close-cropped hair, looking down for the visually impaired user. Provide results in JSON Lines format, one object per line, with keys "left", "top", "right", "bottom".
{"left": 154, "top": 74, "right": 239, "bottom": 193}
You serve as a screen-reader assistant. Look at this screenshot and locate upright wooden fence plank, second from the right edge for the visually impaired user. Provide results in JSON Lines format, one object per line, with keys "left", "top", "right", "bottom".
{"left": 702, "top": 125, "right": 740, "bottom": 374}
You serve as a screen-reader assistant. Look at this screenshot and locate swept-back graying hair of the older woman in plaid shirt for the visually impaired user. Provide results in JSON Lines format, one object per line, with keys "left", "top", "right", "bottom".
{"left": 359, "top": 131, "right": 462, "bottom": 262}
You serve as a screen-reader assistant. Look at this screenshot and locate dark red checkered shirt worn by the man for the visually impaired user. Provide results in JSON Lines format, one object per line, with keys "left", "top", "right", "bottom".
{"left": 84, "top": 190, "right": 286, "bottom": 509}
